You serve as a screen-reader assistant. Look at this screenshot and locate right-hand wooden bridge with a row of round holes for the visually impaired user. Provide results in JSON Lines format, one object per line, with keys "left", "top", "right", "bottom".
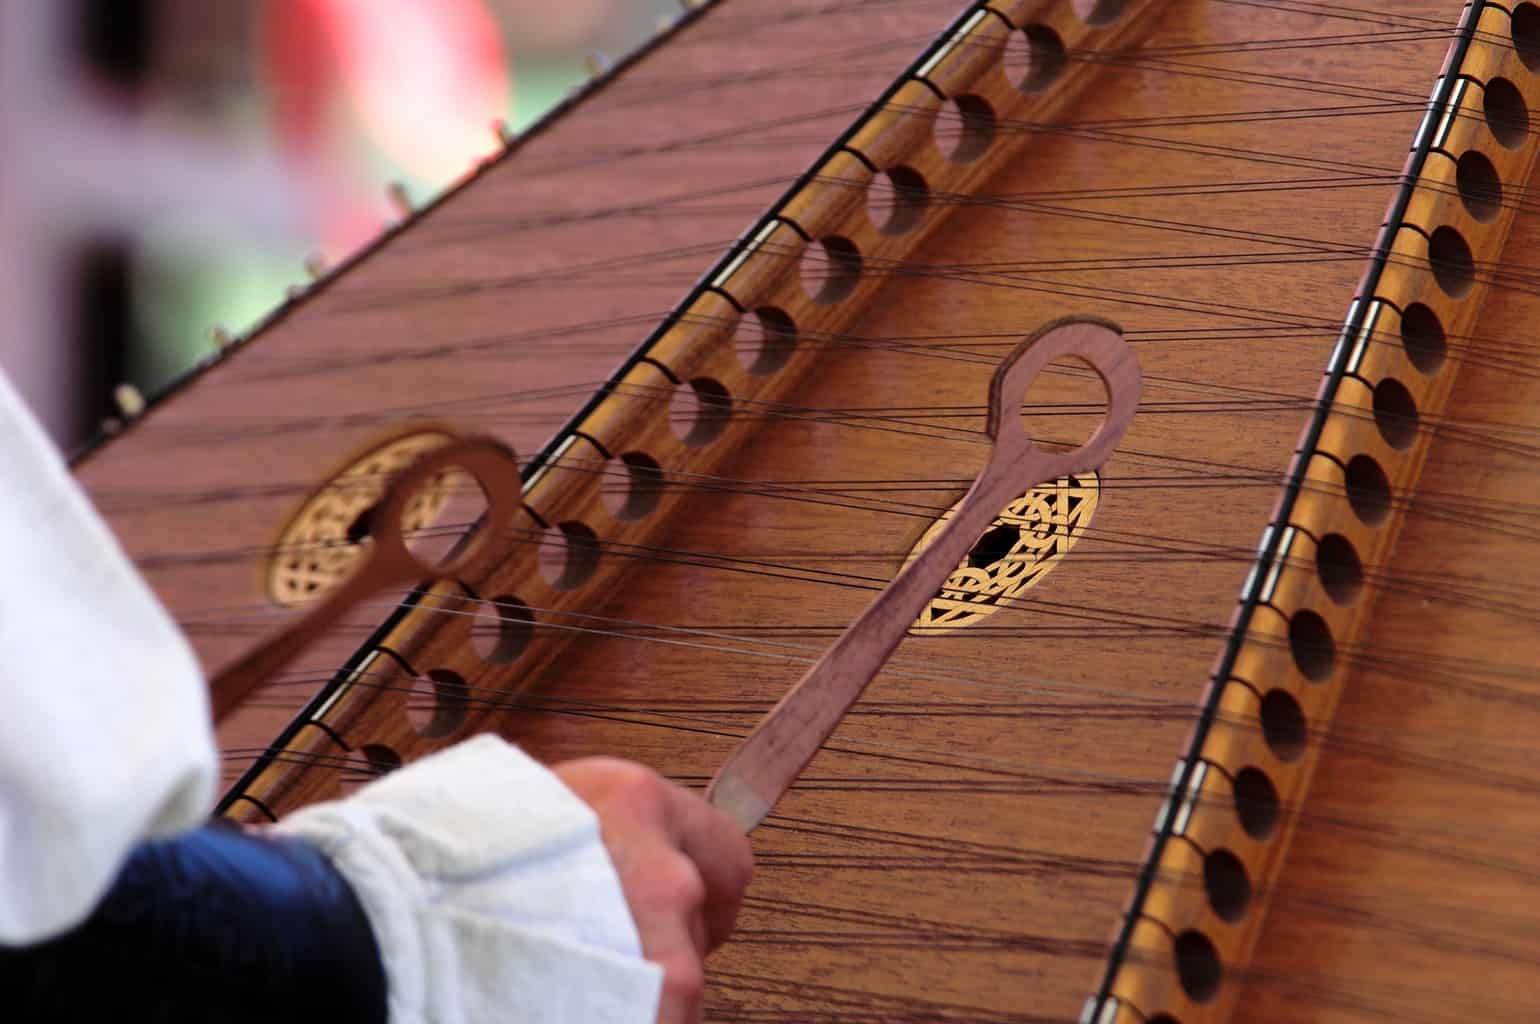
{"left": 1110, "top": 8, "right": 1540, "bottom": 1021}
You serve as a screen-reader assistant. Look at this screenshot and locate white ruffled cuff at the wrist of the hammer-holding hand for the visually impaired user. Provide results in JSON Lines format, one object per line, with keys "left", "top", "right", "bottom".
{"left": 276, "top": 736, "right": 662, "bottom": 1024}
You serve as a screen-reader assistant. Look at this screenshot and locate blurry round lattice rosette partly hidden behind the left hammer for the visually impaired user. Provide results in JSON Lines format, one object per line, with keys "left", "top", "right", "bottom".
{"left": 266, "top": 430, "right": 451, "bottom": 607}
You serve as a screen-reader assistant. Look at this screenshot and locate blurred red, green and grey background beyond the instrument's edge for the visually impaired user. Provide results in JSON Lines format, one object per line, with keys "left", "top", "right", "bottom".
{"left": 0, "top": 0, "right": 681, "bottom": 450}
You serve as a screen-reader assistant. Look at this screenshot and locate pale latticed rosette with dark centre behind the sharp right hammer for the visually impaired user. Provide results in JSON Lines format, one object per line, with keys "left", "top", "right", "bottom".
{"left": 904, "top": 473, "right": 1100, "bottom": 636}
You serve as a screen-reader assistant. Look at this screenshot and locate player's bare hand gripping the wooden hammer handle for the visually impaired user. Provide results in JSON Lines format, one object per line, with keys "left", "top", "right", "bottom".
{"left": 553, "top": 758, "right": 753, "bottom": 1024}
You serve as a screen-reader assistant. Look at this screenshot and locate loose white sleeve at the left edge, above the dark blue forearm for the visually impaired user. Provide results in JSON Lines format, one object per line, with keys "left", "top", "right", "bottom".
{"left": 0, "top": 373, "right": 216, "bottom": 945}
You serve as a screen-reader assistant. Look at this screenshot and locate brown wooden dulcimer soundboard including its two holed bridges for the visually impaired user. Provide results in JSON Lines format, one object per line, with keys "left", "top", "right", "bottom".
{"left": 69, "top": 0, "right": 1540, "bottom": 1024}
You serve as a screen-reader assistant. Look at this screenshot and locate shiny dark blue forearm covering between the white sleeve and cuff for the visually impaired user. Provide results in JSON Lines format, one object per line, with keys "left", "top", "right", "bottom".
{"left": 0, "top": 825, "right": 385, "bottom": 1024}
